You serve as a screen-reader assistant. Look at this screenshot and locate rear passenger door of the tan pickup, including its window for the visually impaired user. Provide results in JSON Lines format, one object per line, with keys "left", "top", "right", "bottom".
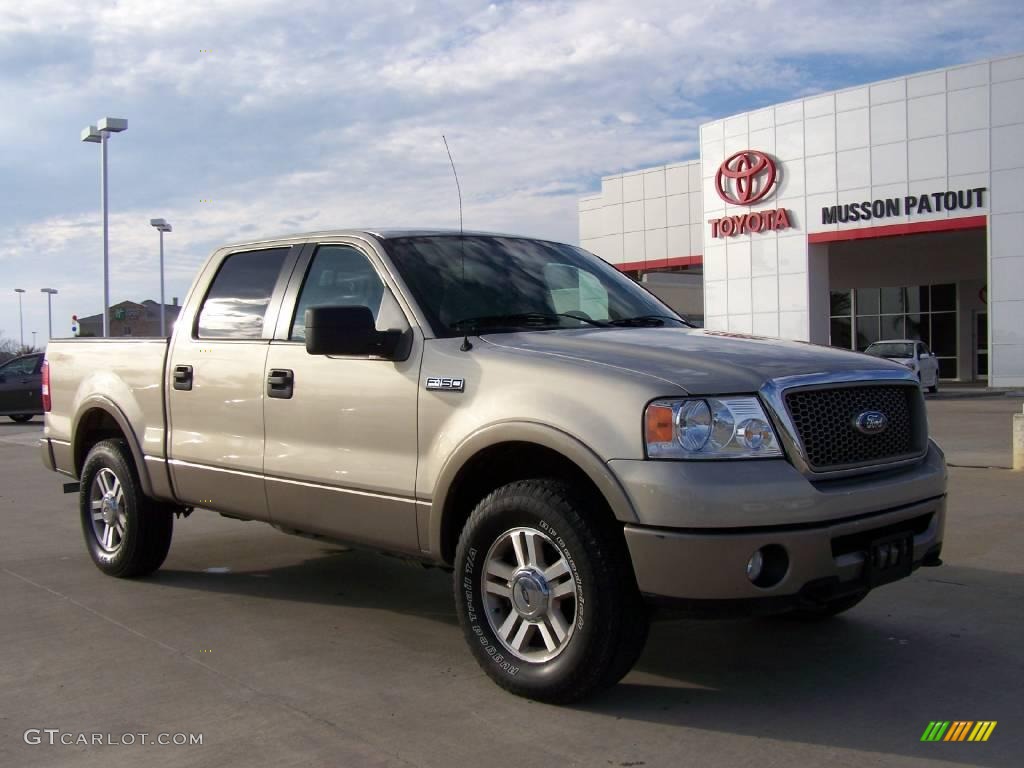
{"left": 166, "top": 246, "right": 301, "bottom": 520}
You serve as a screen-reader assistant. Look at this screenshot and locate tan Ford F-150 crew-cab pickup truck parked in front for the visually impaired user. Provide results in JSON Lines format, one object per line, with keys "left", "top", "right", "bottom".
{"left": 41, "top": 230, "right": 946, "bottom": 702}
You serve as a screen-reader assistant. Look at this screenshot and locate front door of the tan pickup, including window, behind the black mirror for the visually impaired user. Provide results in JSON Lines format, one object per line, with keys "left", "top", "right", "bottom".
{"left": 264, "top": 242, "right": 423, "bottom": 552}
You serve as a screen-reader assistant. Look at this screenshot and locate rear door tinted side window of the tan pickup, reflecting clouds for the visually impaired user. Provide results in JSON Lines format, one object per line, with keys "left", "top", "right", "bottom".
{"left": 199, "top": 248, "right": 288, "bottom": 339}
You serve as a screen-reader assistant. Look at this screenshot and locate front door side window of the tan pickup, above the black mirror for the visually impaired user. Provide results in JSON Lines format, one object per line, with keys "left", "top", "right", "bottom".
{"left": 288, "top": 245, "right": 408, "bottom": 341}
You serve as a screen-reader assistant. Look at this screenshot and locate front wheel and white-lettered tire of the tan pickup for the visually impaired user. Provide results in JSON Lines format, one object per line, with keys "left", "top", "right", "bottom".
{"left": 454, "top": 480, "right": 648, "bottom": 703}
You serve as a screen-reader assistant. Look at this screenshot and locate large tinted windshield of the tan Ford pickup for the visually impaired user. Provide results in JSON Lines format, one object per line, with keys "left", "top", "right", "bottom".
{"left": 384, "top": 234, "right": 686, "bottom": 337}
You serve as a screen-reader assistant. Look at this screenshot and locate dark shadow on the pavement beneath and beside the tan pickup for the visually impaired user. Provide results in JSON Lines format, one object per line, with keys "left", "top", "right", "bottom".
{"left": 153, "top": 550, "right": 1024, "bottom": 766}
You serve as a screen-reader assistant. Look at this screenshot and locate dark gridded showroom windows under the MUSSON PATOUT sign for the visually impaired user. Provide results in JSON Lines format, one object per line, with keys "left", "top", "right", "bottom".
{"left": 829, "top": 283, "right": 957, "bottom": 379}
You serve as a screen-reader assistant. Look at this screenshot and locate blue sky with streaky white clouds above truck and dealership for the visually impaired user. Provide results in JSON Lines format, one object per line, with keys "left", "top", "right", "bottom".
{"left": 0, "top": 0, "right": 1024, "bottom": 343}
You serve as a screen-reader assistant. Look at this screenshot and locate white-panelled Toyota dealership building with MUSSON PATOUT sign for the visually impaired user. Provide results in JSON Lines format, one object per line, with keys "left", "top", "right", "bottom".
{"left": 580, "top": 55, "right": 1024, "bottom": 387}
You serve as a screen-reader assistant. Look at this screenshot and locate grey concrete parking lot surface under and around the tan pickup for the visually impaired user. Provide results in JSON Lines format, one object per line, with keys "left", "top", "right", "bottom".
{"left": 0, "top": 398, "right": 1024, "bottom": 768}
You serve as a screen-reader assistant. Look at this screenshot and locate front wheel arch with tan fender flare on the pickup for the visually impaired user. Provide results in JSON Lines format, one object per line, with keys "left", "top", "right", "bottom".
{"left": 429, "top": 422, "right": 637, "bottom": 564}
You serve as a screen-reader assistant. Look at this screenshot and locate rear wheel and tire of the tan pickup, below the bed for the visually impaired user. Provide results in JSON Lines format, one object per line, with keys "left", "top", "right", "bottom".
{"left": 79, "top": 440, "right": 174, "bottom": 579}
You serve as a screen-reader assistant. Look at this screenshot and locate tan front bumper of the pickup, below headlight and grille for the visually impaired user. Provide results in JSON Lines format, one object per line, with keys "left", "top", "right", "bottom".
{"left": 611, "top": 444, "right": 946, "bottom": 609}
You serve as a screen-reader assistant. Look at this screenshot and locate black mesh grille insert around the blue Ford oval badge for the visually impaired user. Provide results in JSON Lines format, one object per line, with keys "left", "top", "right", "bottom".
{"left": 784, "top": 384, "right": 927, "bottom": 472}
